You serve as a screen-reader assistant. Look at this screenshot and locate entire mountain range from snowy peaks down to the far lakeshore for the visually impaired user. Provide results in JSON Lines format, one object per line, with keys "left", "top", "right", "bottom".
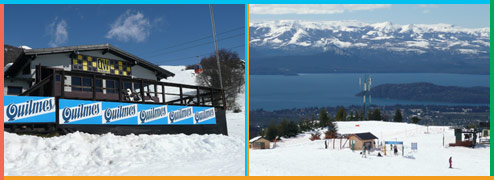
{"left": 249, "top": 20, "right": 490, "bottom": 74}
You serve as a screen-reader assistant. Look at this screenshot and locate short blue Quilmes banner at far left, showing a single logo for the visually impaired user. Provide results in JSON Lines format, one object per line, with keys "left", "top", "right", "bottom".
{"left": 3, "top": 96, "right": 56, "bottom": 123}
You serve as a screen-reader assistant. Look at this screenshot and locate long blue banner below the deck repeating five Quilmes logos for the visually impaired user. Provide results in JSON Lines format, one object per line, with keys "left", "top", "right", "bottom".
{"left": 59, "top": 99, "right": 216, "bottom": 125}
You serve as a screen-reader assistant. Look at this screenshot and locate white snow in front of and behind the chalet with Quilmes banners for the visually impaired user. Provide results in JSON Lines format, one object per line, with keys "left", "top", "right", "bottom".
{"left": 4, "top": 66, "right": 245, "bottom": 176}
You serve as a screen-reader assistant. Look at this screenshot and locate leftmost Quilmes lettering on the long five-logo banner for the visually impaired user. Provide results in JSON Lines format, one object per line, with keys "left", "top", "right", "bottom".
{"left": 61, "top": 103, "right": 101, "bottom": 123}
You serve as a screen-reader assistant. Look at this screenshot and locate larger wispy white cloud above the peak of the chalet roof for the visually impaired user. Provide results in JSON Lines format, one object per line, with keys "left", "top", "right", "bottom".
{"left": 106, "top": 10, "right": 151, "bottom": 42}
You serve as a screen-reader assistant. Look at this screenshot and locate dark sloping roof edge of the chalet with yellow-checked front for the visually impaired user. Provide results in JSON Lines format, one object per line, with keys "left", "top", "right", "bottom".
{"left": 5, "top": 43, "right": 175, "bottom": 78}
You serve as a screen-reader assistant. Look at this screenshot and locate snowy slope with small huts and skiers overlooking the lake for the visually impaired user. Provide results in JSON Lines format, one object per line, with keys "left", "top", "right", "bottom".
{"left": 249, "top": 121, "right": 490, "bottom": 176}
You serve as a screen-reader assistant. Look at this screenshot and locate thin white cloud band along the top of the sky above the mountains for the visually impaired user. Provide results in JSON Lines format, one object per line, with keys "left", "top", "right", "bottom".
{"left": 250, "top": 4, "right": 391, "bottom": 14}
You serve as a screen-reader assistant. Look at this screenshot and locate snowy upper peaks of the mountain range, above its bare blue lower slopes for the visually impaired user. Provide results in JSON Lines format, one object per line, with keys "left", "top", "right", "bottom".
{"left": 250, "top": 20, "right": 490, "bottom": 54}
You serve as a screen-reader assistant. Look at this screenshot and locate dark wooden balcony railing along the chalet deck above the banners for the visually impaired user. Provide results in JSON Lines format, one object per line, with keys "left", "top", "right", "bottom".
{"left": 21, "top": 69, "right": 226, "bottom": 108}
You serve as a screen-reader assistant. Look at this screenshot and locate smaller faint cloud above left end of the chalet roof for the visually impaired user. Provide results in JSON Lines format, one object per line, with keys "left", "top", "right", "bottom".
{"left": 47, "top": 18, "right": 69, "bottom": 47}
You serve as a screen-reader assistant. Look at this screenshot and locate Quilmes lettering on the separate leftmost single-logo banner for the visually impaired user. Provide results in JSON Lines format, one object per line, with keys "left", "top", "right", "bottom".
{"left": 4, "top": 98, "right": 55, "bottom": 121}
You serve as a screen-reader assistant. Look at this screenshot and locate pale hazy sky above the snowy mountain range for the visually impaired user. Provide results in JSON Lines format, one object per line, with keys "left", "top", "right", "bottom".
{"left": 250, "top": 4, "right": 490, "bottom": 28}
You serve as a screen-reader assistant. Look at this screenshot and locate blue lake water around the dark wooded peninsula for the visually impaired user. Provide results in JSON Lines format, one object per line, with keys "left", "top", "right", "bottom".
{"left": 249, "top": 73, "right": 489, "bottom": 110}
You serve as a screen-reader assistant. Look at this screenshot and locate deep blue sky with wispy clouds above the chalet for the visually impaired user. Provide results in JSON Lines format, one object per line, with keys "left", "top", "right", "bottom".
{"left": 4, "top": 5, "right": 245, "bottom": 65}
